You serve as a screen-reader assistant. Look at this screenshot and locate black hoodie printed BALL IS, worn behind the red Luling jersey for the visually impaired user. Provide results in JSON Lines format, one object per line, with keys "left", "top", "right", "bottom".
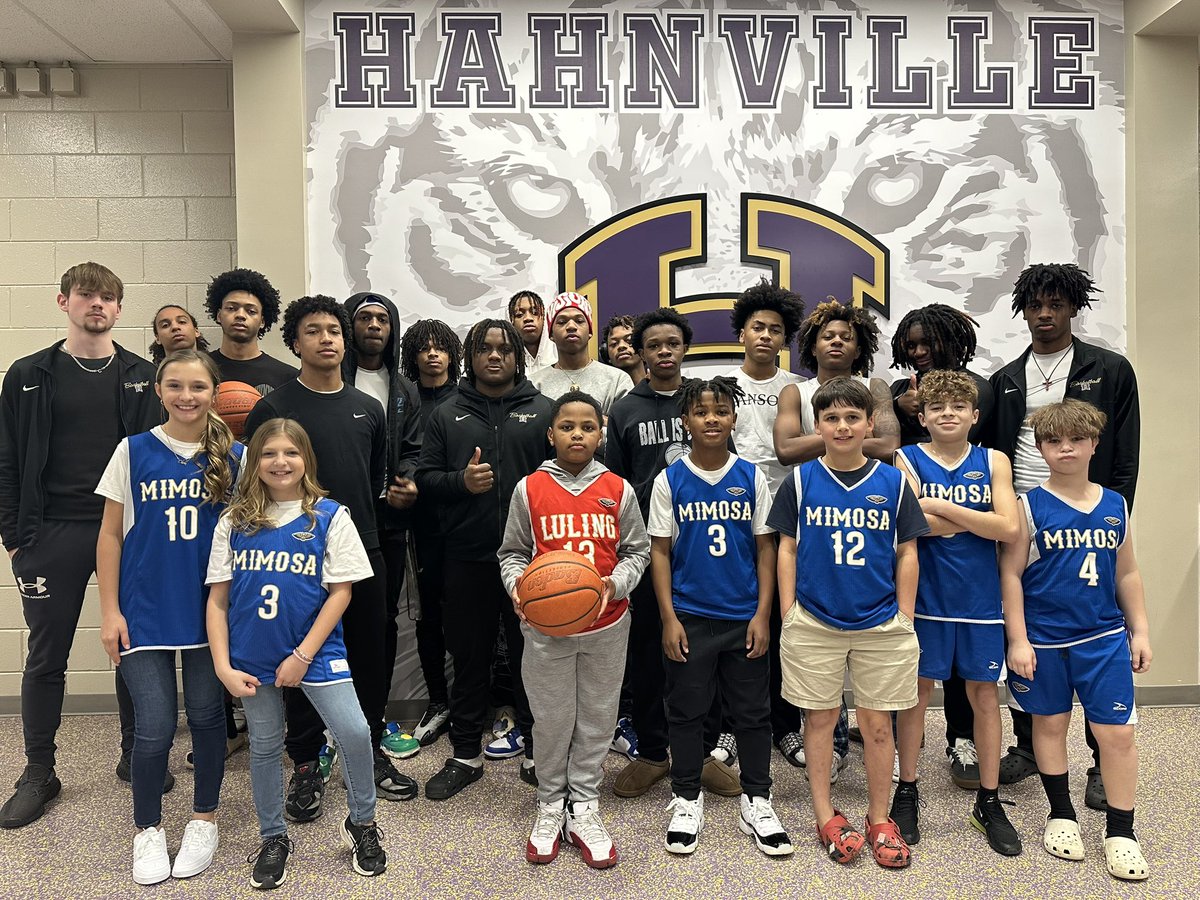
{"left": 604, "top": 378, "right": 690, "bottom": 520}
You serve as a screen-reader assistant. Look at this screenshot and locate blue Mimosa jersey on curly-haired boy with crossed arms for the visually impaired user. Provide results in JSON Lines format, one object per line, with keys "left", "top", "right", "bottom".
{"left": 896, "top": 444, "right": 1003, "bottom": 623}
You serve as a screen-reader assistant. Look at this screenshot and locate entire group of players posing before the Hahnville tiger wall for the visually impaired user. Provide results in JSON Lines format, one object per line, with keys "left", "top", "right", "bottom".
{"left": 0, "top": 256, "right": 1151, "bottom": 889}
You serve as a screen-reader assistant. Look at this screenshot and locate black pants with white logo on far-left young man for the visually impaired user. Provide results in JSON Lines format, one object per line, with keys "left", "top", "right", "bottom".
{"left": 12, "top": 520, "right": 133, "bottom": 768}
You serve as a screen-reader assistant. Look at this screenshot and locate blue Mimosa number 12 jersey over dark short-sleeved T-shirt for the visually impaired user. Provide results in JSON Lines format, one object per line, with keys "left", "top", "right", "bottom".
{"left": 770, "top": 457, "right": 929, "bottom": 631}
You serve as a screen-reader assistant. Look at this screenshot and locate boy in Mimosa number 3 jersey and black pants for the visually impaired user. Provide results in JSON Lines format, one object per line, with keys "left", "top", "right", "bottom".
{"left": 647, "top": 378, "right": 792, "bottom": 856}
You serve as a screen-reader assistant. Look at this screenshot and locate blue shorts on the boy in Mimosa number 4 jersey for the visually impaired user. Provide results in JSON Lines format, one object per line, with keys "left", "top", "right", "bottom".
{"left": 1008, "top": 630, "right": 1138, "bottom": 725}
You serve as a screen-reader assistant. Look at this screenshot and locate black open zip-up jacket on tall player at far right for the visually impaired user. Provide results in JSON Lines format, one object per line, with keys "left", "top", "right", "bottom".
{"left": 985, "top": 337, "right": 1141, "bottom": 509}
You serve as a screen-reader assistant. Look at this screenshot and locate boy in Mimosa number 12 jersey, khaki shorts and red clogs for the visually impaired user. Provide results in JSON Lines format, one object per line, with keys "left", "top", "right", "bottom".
{"left": 769, "top": 378, "right": 929, "bottom": 869}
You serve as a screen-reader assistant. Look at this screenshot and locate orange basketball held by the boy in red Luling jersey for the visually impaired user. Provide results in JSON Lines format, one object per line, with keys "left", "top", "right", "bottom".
{"left": 517, "top": 550, "right": 604, "bottom": 637}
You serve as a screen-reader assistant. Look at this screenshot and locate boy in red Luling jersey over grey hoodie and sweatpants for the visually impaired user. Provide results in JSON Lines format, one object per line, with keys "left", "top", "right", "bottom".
{"left": 498, "top": 391, "right": 650, "bottom": 869}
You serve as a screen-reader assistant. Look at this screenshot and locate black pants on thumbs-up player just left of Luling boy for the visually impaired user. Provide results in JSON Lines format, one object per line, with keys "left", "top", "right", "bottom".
{"left": 443, "top": 559, "right": 533, "bottom": 760}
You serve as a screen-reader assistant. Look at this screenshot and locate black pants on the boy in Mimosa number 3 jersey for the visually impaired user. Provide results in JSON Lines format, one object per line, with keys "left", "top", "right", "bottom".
{"left": 662, "top": 612, "right": 770, "bottom": 800}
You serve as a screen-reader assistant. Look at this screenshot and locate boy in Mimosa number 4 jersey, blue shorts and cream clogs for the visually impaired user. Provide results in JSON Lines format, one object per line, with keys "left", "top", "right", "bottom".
{"left": 1000, "top": 398, "right": 1152, "bottom": 881}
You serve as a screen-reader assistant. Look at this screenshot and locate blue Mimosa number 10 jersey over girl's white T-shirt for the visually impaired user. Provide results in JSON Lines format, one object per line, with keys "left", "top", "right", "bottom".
{"left": 96, "top": 427, "right": 244, "bottom": 655}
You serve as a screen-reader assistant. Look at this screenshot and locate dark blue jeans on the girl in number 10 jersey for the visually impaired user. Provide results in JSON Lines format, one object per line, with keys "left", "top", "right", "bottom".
{"left": 120, "top": 647, "right": 226, "bottom": 828}
